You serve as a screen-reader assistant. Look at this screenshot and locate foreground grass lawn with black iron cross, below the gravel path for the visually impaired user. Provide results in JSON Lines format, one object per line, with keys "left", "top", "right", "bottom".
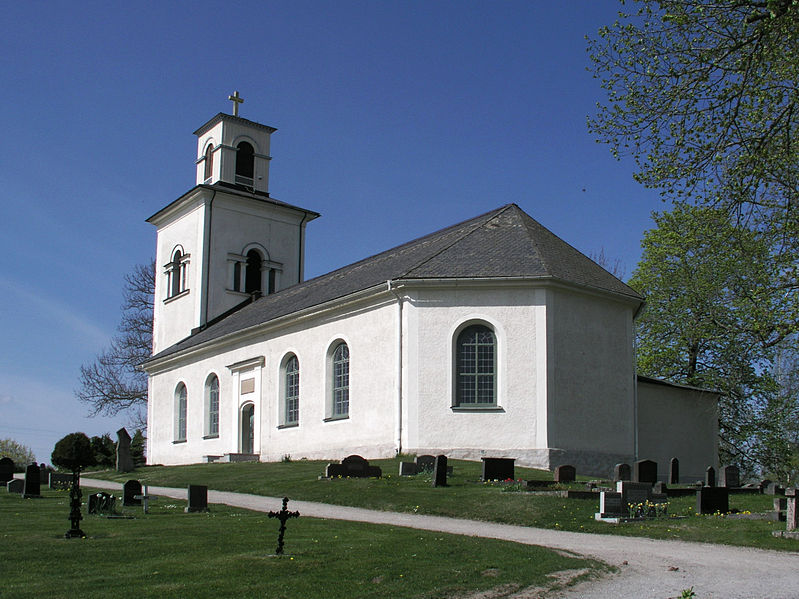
{"left": 0, "top": 490, "right": 606, "bottom": 599}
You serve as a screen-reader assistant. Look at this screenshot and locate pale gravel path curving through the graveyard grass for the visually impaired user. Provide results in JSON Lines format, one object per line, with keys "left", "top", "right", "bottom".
{"left": 81, "top": 479, "right": 799, "bottom": 599}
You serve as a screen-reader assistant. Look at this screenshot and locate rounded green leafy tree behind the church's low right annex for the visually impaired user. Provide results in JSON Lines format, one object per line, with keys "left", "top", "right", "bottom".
{"left": 629, "top": 204, "right": 797, "bottom": 474}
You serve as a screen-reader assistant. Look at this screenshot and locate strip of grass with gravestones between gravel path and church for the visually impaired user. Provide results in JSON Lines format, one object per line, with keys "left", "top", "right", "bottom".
{"left": 86, "top": 456, "right": 799, "bottom": 551}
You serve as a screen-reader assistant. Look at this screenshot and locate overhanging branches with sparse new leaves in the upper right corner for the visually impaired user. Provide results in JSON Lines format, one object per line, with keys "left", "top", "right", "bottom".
{"left": 589, "top": 0, "right": 799, "bottom": 232}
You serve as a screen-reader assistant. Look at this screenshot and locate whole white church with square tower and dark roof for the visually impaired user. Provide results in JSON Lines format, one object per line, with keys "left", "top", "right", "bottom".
{"left": 143, "top": 101, "right": 718, "bottom": 481}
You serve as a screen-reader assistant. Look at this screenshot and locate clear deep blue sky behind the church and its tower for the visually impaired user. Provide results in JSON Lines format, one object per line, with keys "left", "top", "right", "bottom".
{"left": 0, "top": 0, "right": 663, "bottom": 462}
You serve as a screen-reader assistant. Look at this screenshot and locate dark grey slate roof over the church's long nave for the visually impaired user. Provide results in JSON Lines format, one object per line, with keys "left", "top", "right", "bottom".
{"left": 145, "top": 204, "right": 643, "bottom": 364}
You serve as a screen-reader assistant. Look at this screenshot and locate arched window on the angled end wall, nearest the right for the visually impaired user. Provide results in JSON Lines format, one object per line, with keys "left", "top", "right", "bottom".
{"left": 455, "top": 324, "right": 497, "bottom": 407}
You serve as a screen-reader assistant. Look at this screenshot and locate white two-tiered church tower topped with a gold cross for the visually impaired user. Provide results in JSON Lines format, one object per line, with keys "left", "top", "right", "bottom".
{"left": 147, "top": 92, "right": 319, "bottom": 354}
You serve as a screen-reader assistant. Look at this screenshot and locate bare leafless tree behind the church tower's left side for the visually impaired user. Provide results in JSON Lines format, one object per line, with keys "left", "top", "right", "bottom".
{"left": 75, "top": 262, "right": 155, "bottom": 428}
